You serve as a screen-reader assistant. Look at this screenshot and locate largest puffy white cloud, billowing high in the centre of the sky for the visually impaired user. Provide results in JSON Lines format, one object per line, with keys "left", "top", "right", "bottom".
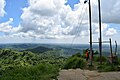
{"left": 21, "top": 0, "right": 89, "bottom": 38}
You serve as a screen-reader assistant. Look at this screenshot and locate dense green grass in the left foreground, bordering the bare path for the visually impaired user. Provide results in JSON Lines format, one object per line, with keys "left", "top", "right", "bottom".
{"left": 0, "top": 64, "right": 59, "bottom": 80}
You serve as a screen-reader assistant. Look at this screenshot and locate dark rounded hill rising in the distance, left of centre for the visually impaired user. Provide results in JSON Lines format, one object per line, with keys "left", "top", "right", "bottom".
{"left": 25, "top": 46, "right": 53, "bottom": 53}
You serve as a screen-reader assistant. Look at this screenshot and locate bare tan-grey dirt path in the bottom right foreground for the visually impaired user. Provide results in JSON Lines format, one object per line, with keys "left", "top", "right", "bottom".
{"left": 58, "top": 69, "right": 120, "bottom": 80}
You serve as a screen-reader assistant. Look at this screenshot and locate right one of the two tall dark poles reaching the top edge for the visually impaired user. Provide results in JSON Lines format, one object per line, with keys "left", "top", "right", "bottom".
{"left": 98, "top": 0, "right": 102, "bottom": 64}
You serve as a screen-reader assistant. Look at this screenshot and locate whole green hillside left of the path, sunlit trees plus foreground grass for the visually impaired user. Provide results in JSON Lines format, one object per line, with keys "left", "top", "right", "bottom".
{"left": 0, "top": 49, "right": 65, "bottom": 80}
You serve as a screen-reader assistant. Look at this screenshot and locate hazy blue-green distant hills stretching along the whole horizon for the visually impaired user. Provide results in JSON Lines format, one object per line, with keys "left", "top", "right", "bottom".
{"left": 0, "top": 43, "right": 120, "bottom": 57}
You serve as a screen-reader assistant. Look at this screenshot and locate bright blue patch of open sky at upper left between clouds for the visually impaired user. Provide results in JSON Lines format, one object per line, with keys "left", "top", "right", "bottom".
{"left": 0, "top": 0, "right": 28, "bottom": 27}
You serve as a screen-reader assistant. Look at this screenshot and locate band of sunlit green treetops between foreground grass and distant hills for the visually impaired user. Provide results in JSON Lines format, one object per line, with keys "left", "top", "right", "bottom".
{"left": 0, "top": 49, "right": 66, "bottom": 70}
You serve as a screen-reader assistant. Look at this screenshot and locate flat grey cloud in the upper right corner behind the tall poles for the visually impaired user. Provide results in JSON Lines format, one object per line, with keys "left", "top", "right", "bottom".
{"left": 92, "top": 0, "right": 120, "bottom": 23}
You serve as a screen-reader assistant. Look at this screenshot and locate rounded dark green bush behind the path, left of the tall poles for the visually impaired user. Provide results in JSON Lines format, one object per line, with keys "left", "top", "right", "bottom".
{"left": 63, "top": 53, "right": 86, "bottom": 69}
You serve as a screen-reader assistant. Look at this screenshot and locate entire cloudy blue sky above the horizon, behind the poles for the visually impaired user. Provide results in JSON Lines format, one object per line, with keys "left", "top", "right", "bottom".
{"left": 0, "top": 0, "right": 120, "bottom": 44}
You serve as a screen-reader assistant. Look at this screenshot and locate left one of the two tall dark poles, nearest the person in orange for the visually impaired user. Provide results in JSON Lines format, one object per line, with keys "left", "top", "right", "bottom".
{"left": 89, "top": 0, "right": 93, "bottom": 65}
